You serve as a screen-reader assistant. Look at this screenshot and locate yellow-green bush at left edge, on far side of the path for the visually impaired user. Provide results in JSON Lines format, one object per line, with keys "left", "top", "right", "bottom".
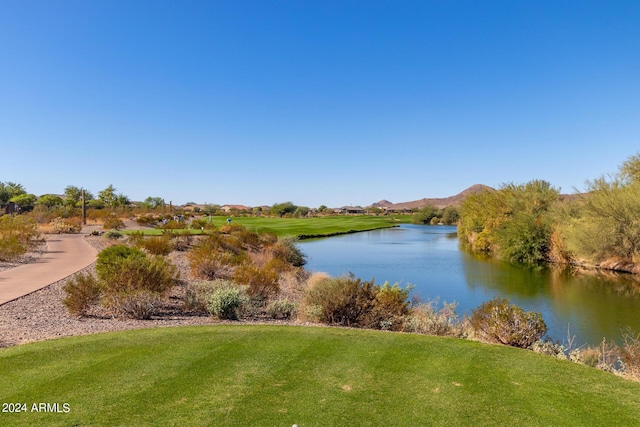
{"left": 0, "top": 215, "right": 40, "bottom": 261}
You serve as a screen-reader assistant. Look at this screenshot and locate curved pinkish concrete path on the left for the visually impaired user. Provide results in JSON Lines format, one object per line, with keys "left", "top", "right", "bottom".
{"left": 0, "top": 234, "right": 97, "bottom": 305}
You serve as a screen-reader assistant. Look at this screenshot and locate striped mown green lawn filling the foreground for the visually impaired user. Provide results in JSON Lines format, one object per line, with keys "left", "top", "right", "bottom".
{"left": 0, "top": 325, "right": 640, "bottom": 427}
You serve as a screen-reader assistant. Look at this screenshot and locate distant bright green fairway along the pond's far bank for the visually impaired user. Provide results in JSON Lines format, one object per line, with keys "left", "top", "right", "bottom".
{"left": 123, "top": 215, "right": 411, "bottom": 238}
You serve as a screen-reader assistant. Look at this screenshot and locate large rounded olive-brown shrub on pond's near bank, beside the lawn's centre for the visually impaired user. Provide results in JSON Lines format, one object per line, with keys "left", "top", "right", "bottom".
{"left": 303, "top": 274, "right": 375, "bottom": 326}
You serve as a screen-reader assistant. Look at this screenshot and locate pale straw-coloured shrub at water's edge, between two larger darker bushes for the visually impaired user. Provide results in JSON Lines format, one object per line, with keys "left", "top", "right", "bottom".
{"left": 404, "top": 299, "right": 466, "bottom": 337}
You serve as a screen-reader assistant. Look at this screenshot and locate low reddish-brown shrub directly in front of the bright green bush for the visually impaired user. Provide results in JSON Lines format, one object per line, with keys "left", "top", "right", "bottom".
{"left": 103, "top": 289, "right": 162, "bottom": 320}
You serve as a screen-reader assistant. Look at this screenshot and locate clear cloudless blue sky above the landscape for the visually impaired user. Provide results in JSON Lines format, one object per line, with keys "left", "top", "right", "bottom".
{"left": 0, "top": 0, "right": 640, "bottom": 207}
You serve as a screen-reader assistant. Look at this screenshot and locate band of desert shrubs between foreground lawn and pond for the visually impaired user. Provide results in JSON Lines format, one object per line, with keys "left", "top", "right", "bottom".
{"left": 56, "top": 224, "right": 640, "bottom": 378}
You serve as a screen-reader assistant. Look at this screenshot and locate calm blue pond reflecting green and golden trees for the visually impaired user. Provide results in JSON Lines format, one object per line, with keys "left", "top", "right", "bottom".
{"left": 299, "top": 224, "right": 640, "bottom": 345}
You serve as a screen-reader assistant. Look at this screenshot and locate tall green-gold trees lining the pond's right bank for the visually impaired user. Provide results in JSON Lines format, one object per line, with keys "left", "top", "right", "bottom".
{"left": 458, "top": 153, "right": 640, "bottom": 272}
